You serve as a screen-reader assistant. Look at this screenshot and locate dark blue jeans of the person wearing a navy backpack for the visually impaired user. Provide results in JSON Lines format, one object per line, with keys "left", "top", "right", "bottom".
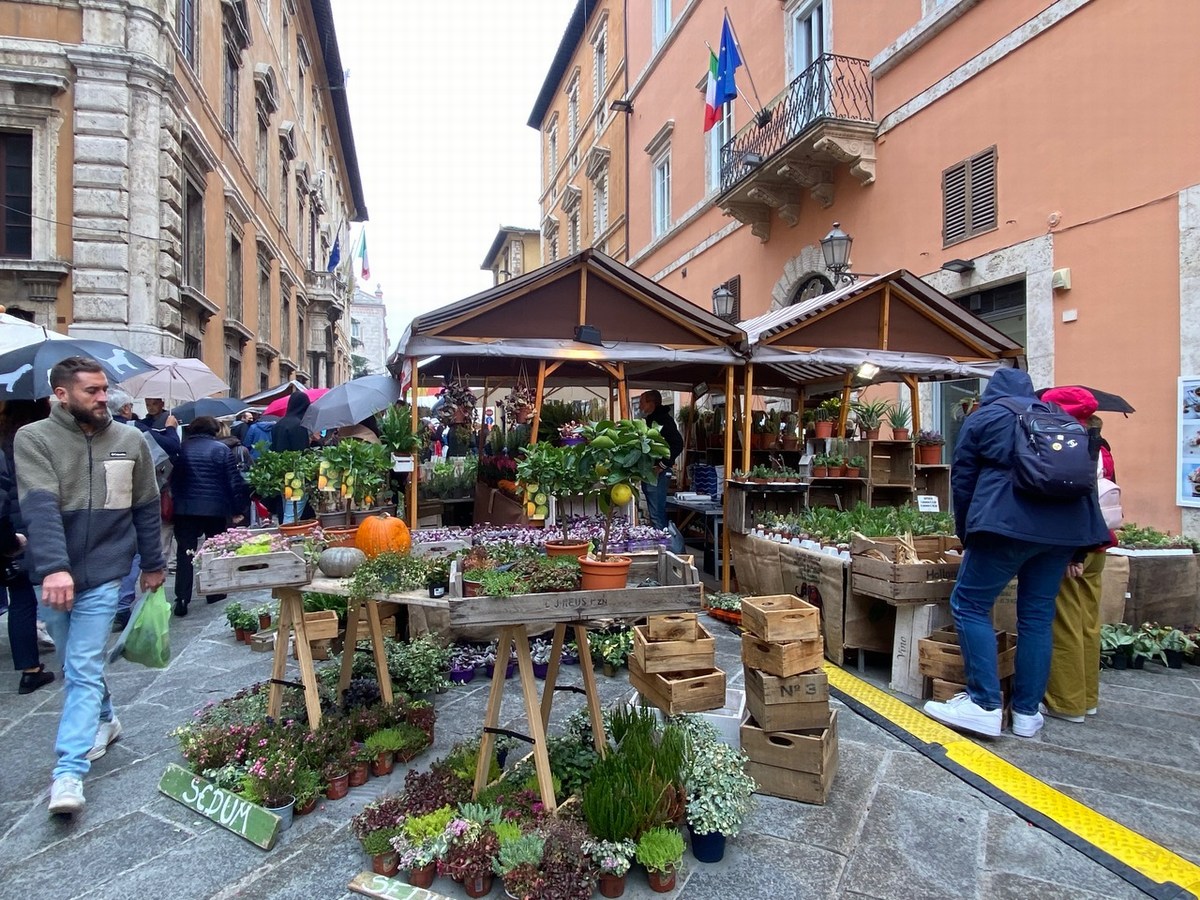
{"left": 950, "top": 533, "right": 1075, "bottom": 715}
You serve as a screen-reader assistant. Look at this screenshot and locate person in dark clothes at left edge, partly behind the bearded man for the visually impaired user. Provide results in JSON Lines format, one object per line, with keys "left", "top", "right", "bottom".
{"left": 0, "top": 400, "right": 54, "bottom": 694}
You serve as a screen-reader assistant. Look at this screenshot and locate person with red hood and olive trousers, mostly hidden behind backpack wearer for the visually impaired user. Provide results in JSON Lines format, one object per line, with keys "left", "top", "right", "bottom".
{"left": 1042, "top": 388, "right": 1117, "bottom": 722}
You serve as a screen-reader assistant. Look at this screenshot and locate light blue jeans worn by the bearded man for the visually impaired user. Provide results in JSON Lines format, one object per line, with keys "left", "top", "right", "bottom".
{"left": 37, "top": 581, "right": 120, "bottom": 778}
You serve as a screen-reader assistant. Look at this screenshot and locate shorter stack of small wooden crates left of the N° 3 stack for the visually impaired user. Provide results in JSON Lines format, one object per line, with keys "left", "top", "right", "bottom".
{"left": 629, "top": 612, "right": 725, "bottom": 715}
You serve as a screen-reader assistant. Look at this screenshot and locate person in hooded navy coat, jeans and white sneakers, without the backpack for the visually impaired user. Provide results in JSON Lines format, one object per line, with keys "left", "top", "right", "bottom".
{"left": 925, "top": 368, "right": 1109, "bottom": 738}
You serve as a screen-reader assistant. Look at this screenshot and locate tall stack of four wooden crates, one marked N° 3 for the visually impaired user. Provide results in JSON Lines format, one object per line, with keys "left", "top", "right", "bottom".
{"left": 742, "top": 594, "right": 838, "bottom": 804}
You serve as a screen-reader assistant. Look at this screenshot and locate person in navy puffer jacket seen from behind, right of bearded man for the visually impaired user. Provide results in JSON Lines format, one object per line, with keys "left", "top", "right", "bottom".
{"left": 170, "top": 415, "right": 248, "bottom": 616}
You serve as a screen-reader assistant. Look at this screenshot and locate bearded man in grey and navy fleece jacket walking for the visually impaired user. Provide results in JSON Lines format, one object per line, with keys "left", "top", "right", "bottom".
{"left": 14, "top": 356, "right": 166, "bottom": 815}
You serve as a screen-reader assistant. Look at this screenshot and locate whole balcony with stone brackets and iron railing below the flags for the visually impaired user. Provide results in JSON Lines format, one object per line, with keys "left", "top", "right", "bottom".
{"left": 716, "top": 53, "right": 877, "bottom": 242}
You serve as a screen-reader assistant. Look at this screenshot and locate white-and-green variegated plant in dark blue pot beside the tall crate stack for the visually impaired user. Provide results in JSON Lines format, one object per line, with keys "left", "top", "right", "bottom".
{"left": 684, "top": 739, "right": 758, "bottom": 863}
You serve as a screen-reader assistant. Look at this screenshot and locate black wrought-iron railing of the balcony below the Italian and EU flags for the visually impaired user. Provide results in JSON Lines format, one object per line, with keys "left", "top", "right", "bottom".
{"left": 721, "top": 53, "right": 875, "bottom": 191}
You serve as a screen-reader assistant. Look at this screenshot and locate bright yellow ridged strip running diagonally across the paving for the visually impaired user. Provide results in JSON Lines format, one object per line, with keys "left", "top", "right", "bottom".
{"left": 826, "top": 664, "right": 1200, "bottom": 898}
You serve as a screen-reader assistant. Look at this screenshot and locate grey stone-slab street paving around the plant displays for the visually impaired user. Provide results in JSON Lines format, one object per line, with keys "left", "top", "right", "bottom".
{"left": 0, "top": 585, "right": 1200, "bottom": 900}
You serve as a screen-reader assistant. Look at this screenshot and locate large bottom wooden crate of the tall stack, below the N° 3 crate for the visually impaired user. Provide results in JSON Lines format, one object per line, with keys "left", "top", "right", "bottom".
{"left": 742, "top": 709, "right": 838, "bottom": 805}
